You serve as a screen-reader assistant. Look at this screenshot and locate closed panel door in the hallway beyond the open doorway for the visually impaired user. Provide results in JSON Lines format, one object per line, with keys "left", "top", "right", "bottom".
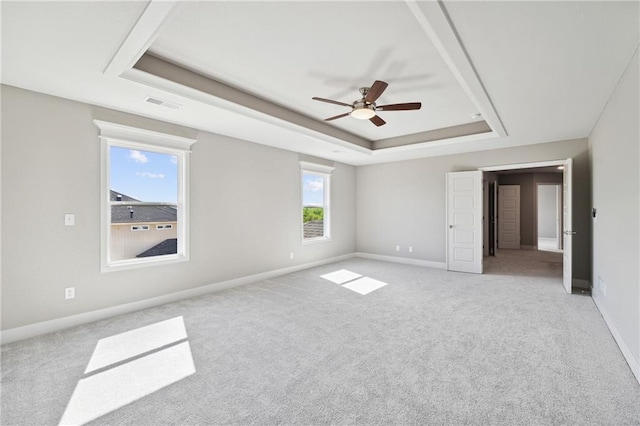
{"left": 498, "top": 185, "right": 520, "bottom": 249}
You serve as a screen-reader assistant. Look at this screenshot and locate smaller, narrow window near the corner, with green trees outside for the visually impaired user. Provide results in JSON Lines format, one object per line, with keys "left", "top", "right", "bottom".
{"left": 300, "top": 161, "right": 333, "bottom": 242}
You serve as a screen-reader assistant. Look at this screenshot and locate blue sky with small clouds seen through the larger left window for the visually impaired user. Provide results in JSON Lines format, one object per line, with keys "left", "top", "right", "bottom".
{"left": 110, "top": 146, "right": 178, "bottom": 203}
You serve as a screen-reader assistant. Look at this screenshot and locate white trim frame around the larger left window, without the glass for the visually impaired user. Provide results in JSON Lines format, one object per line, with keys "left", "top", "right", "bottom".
{"left": 93, "top": 120, "right": 196, "bottom": 272}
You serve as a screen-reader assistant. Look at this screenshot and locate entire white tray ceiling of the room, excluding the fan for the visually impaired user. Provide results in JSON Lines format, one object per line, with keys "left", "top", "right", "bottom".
{"left": 1, "top": 1, "right": 640, "bottom": 165}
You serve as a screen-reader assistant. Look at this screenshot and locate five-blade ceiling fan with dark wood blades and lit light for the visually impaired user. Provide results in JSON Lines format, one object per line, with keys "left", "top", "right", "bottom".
{"left": 312, "top": 80, "right": 422, "bottom": 127}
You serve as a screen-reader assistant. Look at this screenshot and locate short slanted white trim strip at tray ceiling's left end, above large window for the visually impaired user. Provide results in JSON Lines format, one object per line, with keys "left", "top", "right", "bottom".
{"left": 104, "top": 0, "right": 178, "bottom": 76}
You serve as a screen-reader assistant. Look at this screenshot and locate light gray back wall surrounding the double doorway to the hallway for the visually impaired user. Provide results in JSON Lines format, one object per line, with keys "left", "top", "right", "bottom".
{"left": 356, "top": 139, "right": 591, "bottom": 280}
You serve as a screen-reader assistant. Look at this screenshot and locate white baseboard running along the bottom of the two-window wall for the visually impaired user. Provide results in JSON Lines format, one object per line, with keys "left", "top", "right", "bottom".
{"left": 0, "top": 253, "right": 355, "bottom": 344}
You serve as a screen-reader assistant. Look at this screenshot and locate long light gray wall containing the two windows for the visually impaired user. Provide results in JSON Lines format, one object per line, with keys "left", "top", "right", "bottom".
{"left": 2, "top": 86, "right": 355, "bottom": 330}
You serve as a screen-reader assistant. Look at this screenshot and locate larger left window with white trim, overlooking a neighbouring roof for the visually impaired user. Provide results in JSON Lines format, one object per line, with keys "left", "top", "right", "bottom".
{"left": 94, "top": 120, "right": 195, "bottom": 271}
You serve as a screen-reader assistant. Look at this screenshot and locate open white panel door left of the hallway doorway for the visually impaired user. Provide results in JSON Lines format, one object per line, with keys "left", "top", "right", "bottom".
{"left": 447, "top": 171, "right": 482, "bottom": 274}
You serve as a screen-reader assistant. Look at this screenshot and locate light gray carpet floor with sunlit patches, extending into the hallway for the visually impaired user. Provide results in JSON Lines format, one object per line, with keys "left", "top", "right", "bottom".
{"left": 0, "top": 250, "right": 640, "bottom": 425}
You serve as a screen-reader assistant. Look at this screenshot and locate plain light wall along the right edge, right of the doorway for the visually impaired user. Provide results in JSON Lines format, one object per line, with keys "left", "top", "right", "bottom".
{"left": 589, "top": 47, "right": 640, "bottom": 380}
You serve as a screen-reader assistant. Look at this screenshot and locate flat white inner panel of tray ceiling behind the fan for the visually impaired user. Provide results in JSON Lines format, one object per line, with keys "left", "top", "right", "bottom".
{"left": 149, "top": 2, "right": 477, "bottom": 140}
